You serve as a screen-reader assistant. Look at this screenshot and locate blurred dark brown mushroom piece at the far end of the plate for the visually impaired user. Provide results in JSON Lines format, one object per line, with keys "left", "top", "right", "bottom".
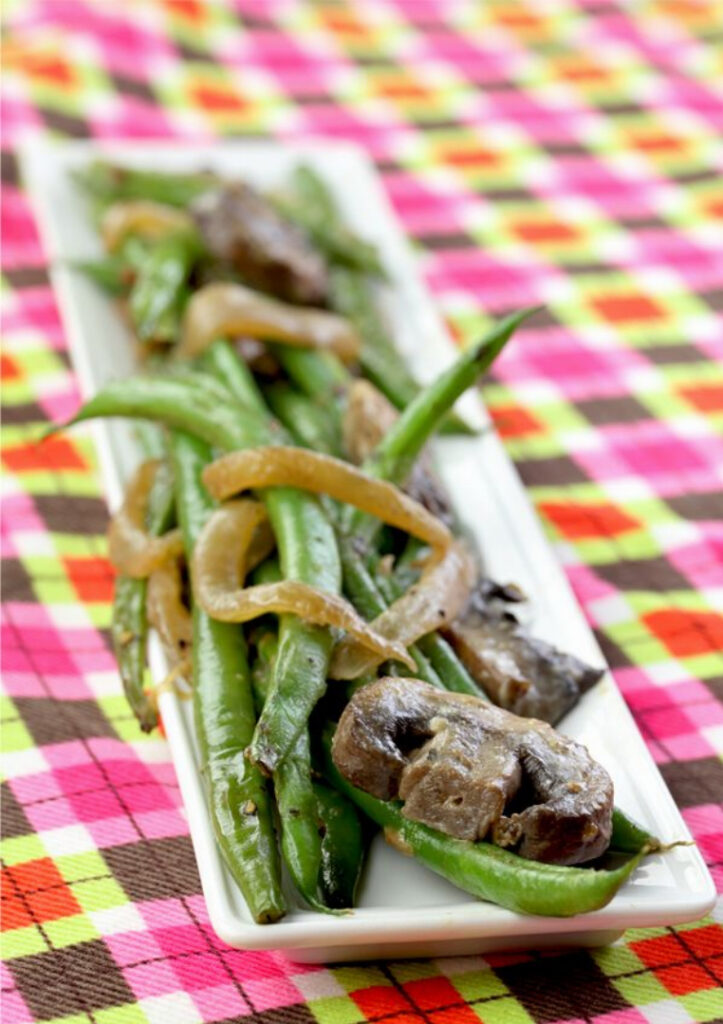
{"left": 193, "top": 182, "right": 329, "bottom": 305}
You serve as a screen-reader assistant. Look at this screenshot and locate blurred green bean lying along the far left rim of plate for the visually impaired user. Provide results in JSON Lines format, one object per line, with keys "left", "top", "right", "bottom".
{"left": 74, "top": 161, "right": 218, "bottom": 208}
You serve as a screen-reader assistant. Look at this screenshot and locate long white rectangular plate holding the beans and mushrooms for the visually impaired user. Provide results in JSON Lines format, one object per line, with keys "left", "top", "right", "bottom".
{"left": 23, "top": 142, "right": 715, "bottom": 962}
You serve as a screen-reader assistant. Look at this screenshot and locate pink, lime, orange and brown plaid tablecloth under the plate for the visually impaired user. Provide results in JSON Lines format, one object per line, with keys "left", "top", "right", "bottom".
{"left": 2, "top": 0, "right": 723, "bottom": 1024}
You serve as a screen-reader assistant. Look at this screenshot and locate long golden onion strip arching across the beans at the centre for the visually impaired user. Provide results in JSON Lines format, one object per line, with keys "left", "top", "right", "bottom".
{"left": 203, "top": 444, "right": 453, "bottom": 562}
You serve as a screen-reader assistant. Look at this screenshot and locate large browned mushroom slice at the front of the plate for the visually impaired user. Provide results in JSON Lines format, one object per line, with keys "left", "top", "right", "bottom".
{"left": 333, "top": 678, "right": 613, "bottom": 864}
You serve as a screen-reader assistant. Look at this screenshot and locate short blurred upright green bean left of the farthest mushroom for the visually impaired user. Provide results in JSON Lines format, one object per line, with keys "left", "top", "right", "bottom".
{"left": 128, "top": 231, "right": 202, "bottom": 343}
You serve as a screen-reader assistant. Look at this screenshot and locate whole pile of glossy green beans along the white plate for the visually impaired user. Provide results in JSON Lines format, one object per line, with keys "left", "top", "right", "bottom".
{"left": 57, "top": 164, "right": 657, "bottom": 923}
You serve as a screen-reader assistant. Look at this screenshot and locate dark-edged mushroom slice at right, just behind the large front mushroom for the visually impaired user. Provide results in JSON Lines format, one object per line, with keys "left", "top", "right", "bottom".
{"left": 444, "top": 580, "right": 604, "bottom": 725}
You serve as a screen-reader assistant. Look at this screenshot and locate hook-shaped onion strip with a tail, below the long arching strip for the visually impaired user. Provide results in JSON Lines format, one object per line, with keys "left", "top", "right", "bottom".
{"left": 192, "top": 501, "right": 414, "bottom": 669}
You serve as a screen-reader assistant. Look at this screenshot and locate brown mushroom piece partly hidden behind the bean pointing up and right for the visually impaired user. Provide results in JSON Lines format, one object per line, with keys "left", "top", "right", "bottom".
{"left": 343, "top": 379, "right": 453, "bottom": 526}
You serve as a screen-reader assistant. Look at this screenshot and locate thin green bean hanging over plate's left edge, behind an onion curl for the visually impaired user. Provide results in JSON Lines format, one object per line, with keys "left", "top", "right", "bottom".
{"left": 111, "top": 454, "right": 175, "bottom": 732}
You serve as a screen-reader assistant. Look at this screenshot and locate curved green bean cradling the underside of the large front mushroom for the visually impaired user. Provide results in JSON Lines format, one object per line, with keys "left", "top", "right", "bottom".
{"left": 325, "top": 737, "right": 648, "bottom": 918}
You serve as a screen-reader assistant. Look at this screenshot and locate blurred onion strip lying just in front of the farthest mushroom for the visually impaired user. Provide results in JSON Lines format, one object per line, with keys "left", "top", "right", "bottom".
{"left": 177, "top": 281, "right": 359, "bottom": 362}
